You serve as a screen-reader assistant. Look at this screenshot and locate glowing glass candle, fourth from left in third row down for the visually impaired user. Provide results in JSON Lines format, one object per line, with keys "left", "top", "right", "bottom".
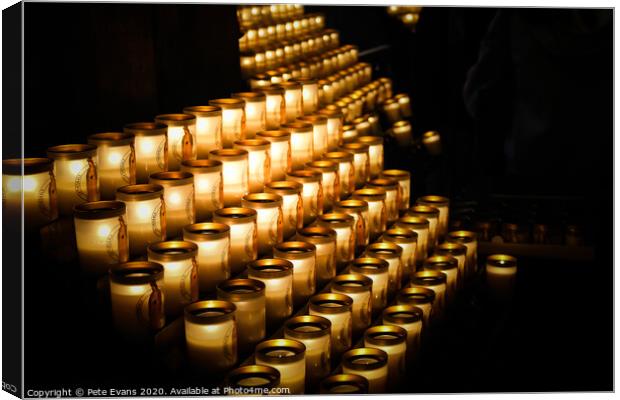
{"left": 213, "top": 207, "right": 258, "bottom": 275}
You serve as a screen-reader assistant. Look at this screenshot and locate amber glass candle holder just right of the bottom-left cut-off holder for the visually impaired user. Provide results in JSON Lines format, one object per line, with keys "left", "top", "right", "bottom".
{"left": 254, "top": 339, "right": 306, "bottom": 394}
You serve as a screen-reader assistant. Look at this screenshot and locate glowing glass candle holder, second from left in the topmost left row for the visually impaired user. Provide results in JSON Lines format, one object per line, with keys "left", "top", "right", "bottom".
{"left": 47, "top": 144, "right": 99, "bottom": 215}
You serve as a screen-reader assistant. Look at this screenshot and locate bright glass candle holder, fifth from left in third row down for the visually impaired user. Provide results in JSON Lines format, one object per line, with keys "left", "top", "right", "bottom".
{"left": 241, "top": 193, "right": 284, "bottom": 256}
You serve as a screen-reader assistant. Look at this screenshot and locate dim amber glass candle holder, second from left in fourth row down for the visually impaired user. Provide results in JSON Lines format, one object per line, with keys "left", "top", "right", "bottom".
{"left": 217, "top": 279, "right": 266, "bottom": 354}
